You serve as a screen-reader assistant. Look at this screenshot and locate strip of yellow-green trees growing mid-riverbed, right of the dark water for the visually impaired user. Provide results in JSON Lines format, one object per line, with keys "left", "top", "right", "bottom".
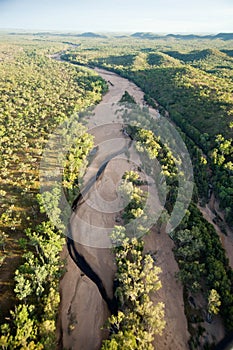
{"left": 101, "top": 171, "right": 165, "bottom": 350}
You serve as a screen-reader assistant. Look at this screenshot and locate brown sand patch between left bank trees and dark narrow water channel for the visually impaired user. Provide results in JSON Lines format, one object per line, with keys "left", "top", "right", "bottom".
{"left": 60, "top": 251, "right": 109, "bottom": 350}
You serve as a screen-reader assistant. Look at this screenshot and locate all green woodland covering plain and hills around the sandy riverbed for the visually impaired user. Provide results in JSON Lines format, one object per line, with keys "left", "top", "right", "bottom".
{"left": 0, "top": 33, "right": 233, "bottom": 350}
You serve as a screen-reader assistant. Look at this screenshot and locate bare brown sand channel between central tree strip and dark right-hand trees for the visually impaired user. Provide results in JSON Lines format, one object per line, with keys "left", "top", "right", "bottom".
{"left": 144, "top": 230, "right": 189, "bottom": 350}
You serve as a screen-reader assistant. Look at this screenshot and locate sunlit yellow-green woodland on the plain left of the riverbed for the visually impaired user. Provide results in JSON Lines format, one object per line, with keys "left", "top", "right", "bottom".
{"left": 0, "top": 38, "right": 107, "bottom": 350}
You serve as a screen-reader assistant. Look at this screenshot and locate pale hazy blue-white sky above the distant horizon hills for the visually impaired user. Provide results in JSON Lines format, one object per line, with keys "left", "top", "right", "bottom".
{"left": 0, "top": 0, "right": 233, "bottom": 33}
